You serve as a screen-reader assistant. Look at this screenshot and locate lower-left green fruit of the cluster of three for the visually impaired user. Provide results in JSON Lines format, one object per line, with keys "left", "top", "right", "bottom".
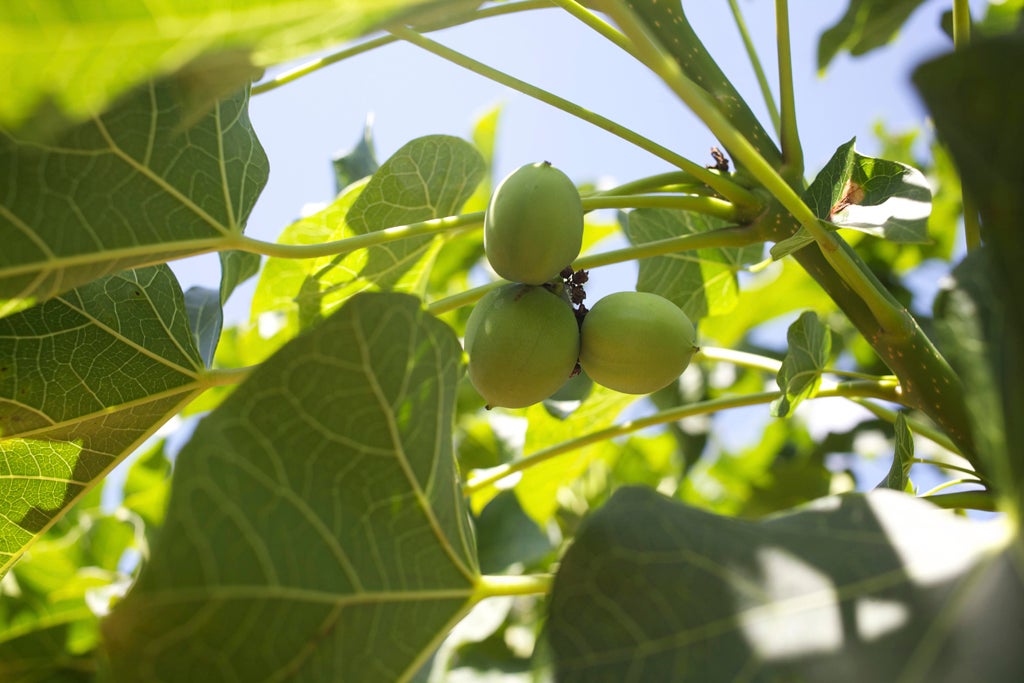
{"left": 466, "top": 285, "right": 580, "bottom": 408}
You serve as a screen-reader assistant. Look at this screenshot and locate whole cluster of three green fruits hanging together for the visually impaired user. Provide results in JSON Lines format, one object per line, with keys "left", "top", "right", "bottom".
{"left": 465, "top": 162, "right": 696, "bottom": 408}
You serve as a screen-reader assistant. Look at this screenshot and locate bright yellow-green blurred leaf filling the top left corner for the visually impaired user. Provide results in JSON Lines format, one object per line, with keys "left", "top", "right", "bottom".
{"left": 0, "top": 0, "right": 456, "bottom": 132}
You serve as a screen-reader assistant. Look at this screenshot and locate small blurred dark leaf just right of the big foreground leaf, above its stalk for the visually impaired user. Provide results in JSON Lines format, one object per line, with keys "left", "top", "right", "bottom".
{"left": 476, "top": 490, "right": 553, "bottom": 573}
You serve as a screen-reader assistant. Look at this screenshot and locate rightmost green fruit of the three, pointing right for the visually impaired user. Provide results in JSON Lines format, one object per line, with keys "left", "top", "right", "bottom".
{"left": 580, "top": 292, "right": 696, "bottom": 393}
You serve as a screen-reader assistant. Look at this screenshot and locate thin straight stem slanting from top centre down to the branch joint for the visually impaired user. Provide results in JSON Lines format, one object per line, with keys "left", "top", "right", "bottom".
{"left": 391, "top": 28, "right": 763, "bottom": 217}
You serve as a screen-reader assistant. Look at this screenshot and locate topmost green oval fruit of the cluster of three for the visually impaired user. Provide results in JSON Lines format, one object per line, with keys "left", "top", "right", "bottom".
{"left": 483, "top": 162, "right": 583, "bottom": 285}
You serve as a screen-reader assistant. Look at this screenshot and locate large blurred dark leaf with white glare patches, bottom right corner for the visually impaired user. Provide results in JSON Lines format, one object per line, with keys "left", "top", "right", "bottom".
{"left": 548, "top": 487, "right": 1024, "bottom": 683}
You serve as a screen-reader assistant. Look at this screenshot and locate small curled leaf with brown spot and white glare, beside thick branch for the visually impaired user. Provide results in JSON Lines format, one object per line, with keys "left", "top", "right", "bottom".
{"left": 771, "top": 139, "right": 932, "bottom": 259}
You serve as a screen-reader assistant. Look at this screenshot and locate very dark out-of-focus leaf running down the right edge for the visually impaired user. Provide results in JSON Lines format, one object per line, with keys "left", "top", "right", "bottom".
{"left": 913, "top": 34, "right": 1024, "bottom": 518}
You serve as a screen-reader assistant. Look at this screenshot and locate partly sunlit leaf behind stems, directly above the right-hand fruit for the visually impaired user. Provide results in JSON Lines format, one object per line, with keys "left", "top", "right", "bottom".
{"left": 626, "top": 209, "right": 762, "bottom": 321}
